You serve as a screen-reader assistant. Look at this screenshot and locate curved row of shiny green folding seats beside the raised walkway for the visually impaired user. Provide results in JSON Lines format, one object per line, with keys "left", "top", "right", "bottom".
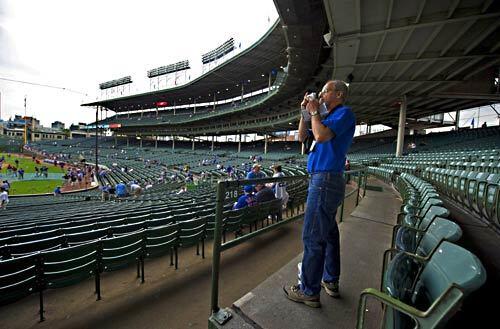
{"left": 358, "top": 173, "right": 486, "bottom": 328}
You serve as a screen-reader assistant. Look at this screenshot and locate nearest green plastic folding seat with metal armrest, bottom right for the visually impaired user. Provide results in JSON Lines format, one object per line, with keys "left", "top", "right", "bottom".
{"left": 356, "top": 241, "right": 486, "bottom": 328}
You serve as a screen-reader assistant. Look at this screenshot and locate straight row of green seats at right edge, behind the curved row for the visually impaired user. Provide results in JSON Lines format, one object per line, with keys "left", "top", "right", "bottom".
{"left": 422, "top": 168, "right": 500, "bottom": 226}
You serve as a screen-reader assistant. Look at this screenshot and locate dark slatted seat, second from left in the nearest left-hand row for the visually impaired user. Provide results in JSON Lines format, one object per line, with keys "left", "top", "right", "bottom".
{"left": 40, "top": 241, "right": 101, "bottom": 321}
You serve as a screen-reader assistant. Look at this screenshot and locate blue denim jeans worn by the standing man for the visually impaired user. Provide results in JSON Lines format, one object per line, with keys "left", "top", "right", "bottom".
{"left": 300, "top": 172, "right": 345, "bottom": 296}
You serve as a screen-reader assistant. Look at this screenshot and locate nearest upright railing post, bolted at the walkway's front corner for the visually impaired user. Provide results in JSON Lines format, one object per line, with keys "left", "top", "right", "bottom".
{"left": 210, "top": 181, "right": 231, "bottom": 325}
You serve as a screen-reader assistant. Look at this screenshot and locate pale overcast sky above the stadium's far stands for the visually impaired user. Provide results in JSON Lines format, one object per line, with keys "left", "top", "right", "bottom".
{"left": 0, "top": 0, "right": 278, "bottom": 126}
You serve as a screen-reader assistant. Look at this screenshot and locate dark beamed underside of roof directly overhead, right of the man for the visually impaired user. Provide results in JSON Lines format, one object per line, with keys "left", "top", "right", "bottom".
{"left": 325, "top": 0, "right": 500, "bottom": 124}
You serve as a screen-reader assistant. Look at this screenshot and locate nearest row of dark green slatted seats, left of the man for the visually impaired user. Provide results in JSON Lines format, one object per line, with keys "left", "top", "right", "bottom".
{"left": 0, "top": 200, "right": 288, "bottom": 321}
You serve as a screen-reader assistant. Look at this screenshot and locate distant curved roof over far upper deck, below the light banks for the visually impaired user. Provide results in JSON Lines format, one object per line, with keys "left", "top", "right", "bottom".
{"left": 82, "top": 21, "right": 287, "bottom": 112}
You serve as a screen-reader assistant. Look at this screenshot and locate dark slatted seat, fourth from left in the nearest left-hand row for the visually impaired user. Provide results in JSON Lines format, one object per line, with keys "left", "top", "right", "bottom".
{"left": 144, "top": 223, "right": 179, "bottom": 269}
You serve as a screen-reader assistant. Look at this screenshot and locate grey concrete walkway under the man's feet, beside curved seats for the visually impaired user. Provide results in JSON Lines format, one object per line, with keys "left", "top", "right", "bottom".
{"left": 221, "top": 180, "right": 401, "bottom": 329}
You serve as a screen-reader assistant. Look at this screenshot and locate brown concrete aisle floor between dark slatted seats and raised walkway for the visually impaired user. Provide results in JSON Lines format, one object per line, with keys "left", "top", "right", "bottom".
{"left": 0, "top": 186, "right": 364, "bottom": 329}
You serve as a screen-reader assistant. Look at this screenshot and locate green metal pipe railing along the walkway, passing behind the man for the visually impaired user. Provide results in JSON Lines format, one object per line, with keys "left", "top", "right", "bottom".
{"left": 208, "top": 169, "right": 367, "bottom": 328}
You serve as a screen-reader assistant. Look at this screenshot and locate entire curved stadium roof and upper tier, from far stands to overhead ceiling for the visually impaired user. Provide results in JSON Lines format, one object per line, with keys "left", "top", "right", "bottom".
{"left": 84, "top": 0, "right": 500, "bottom": 135}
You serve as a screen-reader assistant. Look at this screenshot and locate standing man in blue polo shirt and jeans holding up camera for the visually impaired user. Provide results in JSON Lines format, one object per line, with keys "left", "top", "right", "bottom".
{"left": 284, "top": 80, "right": 356, "bottom": 307}
